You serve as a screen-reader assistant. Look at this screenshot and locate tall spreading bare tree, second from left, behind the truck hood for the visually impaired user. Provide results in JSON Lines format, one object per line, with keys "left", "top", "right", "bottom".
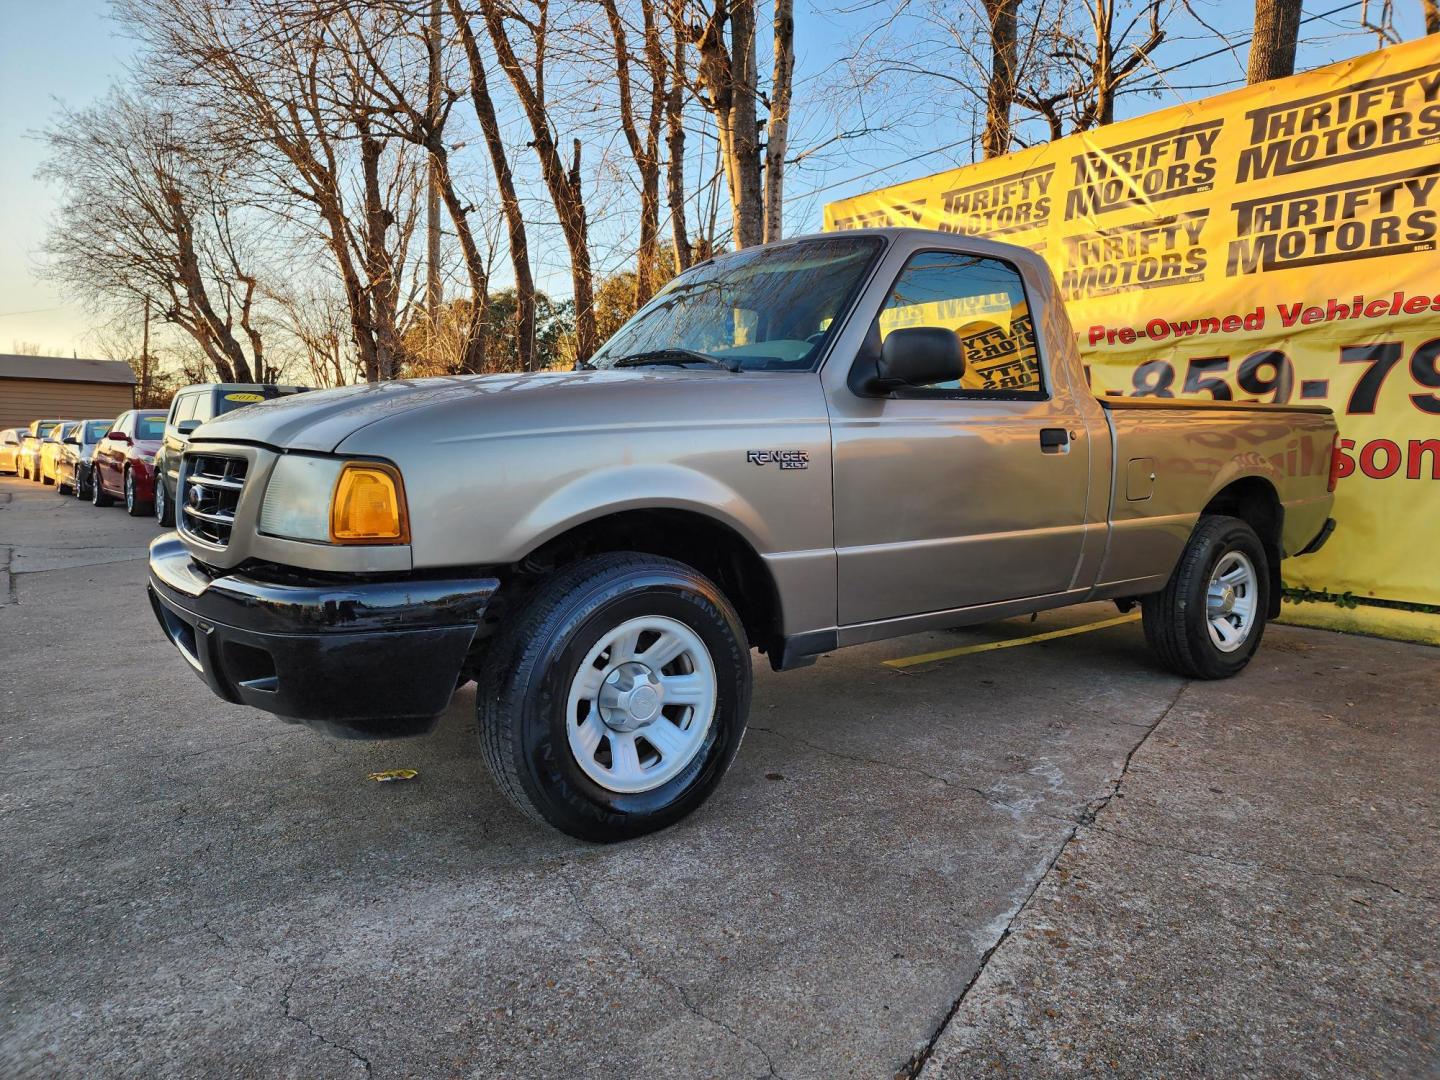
{"left": 117, "top": 0, "right": 423, "bottom": 380}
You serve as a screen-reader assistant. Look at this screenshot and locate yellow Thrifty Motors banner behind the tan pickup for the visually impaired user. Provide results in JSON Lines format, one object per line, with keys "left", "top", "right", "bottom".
{"left": 825, "top": 36, "right": 1440, "bottom": 641}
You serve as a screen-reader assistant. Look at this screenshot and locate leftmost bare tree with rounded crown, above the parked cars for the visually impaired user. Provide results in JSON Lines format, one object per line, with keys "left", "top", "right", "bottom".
{"left": 42, "top": 91, "right": 266, "bottom": 382}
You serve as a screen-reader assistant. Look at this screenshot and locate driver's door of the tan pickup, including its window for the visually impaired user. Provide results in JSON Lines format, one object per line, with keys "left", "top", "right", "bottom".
{"left": 831, "top": 251, "right": 1103, "bottom": 625}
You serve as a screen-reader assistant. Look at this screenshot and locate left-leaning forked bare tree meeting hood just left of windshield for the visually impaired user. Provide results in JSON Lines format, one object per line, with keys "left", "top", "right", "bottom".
{"left": 480, "top": 0, "right": 599, "bottom": 360}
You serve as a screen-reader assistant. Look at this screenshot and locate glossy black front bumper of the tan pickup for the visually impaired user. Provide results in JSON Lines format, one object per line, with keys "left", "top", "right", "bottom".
{"left": 150, "top": 533, "right": 500, "bottom": 739}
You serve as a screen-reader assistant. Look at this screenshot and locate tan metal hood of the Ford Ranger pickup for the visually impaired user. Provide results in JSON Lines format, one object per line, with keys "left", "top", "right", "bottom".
{"left": 192, "top": 369, "right": 824, "bottom": 456}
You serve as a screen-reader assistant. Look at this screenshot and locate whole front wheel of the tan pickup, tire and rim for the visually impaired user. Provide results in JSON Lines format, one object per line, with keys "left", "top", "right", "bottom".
{"left": 475, "top": 553, "right": 750, "bottom": 842}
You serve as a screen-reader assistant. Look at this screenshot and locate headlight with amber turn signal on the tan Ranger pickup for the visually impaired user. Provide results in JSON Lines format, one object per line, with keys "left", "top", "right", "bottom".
{"left": 259, "top": 454, "right": 410, "bottom": 544}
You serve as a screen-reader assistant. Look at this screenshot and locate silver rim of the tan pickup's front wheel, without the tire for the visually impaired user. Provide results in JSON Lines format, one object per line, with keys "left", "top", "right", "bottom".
{"left": 566, "top": 615, "right": 717, "bottom": 795}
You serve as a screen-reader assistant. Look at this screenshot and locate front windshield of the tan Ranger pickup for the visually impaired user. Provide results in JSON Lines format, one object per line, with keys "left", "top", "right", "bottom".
{"left": 590, "top": 236, "right": 883, "bottom": 372}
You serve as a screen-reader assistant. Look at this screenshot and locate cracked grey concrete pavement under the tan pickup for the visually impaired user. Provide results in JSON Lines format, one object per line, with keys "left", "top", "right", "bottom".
{"left": 0, "top": 478, "right": 1440, "bottom": 1077}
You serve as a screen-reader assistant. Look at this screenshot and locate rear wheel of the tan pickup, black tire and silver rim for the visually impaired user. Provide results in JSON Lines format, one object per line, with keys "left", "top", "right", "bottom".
{"left": 1140, "top": 517, "right": 1273, "bottom": 678}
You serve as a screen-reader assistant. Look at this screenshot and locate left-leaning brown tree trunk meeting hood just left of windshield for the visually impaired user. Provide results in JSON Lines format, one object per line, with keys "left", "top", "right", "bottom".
{"left": 481, "top": 0, "right": 599, "bottom": 360}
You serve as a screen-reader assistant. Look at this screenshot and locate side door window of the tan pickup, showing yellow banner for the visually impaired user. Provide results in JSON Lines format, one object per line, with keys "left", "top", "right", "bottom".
{"left": 878, "top": 251, "right": 1044, "bottom": 397}
